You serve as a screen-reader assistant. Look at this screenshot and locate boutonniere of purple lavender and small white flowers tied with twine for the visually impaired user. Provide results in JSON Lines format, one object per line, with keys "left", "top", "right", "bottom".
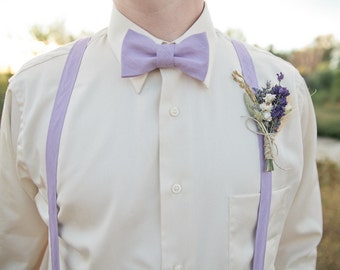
{"left": 232, "top": 71, "right": 292, "bottom": 172}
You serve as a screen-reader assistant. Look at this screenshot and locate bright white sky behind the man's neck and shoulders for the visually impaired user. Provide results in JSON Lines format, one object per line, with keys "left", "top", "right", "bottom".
{"left": 0, "top": 0, "right": 340, "bottom": 71}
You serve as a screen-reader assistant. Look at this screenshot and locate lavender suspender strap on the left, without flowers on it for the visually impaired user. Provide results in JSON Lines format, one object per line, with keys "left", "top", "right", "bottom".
{"left": 46, "top": 38, "right": 89, "bottom": 270}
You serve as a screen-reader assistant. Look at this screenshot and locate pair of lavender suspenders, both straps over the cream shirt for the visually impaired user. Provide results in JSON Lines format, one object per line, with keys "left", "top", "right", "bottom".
{"left": 46, "top": 38, "right": 272, "bottom": 270}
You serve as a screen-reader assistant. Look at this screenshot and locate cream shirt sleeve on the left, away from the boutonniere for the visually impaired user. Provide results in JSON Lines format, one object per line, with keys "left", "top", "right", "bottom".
{"left": 0, "top": 89, "right": 48, "bottom": 270}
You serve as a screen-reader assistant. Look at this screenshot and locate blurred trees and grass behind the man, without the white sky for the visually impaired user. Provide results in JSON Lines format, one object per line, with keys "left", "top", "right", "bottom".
{"left": 0, "top": 26, "right": 340, "bottom": 270}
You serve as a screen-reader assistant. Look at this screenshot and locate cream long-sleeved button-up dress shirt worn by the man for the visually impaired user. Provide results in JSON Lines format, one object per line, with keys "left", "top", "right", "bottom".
{"left": 0, "top": 2, "right": 322, "bottom": 270}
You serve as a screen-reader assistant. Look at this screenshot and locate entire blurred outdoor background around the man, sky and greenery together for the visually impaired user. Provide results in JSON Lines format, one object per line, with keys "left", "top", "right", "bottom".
{"left": 0, "top": 0, "right": 340, "bottom": 270}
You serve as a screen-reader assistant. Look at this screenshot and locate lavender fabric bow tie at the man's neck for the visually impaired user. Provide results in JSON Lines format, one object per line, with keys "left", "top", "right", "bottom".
{"left": 121, "top": 30, "right": 209, "bottom": 81}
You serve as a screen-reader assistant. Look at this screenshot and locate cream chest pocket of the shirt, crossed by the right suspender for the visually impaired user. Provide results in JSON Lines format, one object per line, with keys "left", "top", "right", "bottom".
{"left": 228, "top": 187, "right": 289, "bottom": 270}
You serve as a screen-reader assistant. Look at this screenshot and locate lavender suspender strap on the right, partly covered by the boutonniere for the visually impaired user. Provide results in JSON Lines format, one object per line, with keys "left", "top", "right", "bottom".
{"left": 232, "top": 40, "right": 272, "bottom": 270}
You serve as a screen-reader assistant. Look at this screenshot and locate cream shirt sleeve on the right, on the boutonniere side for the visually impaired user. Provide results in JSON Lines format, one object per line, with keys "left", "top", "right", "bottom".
{"left": 275, "top": 73, "right": 322, "bottom": 270}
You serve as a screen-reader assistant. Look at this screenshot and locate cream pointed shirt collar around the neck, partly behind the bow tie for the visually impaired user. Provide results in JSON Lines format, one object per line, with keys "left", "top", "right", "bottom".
{"left": 108, "top": 3, "right": 216, "bottom": 94}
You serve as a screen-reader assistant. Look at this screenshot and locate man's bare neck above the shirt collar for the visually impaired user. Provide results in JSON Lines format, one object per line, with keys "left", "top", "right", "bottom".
{"left": 114, "top": 0, "right": 204, "bottom": 42}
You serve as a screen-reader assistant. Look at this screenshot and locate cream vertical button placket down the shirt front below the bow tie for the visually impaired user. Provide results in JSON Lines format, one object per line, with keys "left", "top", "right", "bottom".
{"left": 159, "top": 69, "right": 191, "bottom": 270}
